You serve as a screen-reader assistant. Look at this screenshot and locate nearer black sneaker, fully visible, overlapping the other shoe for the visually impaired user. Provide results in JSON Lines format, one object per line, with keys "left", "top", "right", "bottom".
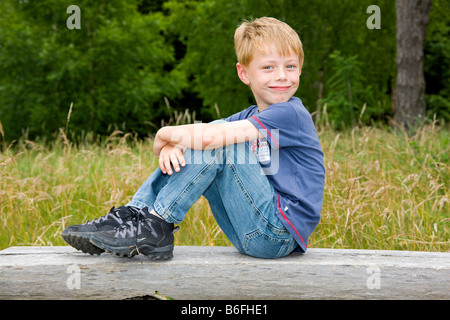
{"left": 91, "top": 208, "right": 178, "bottom": 260}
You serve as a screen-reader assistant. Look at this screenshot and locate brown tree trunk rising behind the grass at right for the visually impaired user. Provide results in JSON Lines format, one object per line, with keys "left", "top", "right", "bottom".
{"left": 394, "top": 0, "right": 432, "bottom": 129}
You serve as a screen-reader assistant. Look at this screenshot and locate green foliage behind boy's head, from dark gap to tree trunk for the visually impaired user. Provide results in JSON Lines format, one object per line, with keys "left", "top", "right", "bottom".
{"left": 164, "top": 0, "right": 395, "bottom": 125}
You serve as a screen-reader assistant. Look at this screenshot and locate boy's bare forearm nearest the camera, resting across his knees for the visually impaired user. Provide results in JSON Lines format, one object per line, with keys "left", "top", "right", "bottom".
{"left": 153, "top": 120, "right": 263, "bottom": 157}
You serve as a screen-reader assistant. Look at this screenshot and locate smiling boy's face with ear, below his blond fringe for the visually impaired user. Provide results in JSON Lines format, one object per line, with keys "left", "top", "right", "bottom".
{"left": 236, "top": 48, "right": 302, "bottom": 111}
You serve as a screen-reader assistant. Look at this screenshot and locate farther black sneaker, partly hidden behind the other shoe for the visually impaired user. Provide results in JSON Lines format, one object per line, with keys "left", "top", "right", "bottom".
{"left": 62, "top": 206, "right": 137, "bottom": 255}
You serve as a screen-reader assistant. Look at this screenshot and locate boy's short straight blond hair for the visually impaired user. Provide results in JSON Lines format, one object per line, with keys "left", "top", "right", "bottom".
{"left": 234, "top": 17, "right": 304, "bottom": 66}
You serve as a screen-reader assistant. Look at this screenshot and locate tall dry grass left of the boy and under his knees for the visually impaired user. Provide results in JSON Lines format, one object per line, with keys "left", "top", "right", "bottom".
{"left": 0, "top": 131, "right": 228, "bottom": 249}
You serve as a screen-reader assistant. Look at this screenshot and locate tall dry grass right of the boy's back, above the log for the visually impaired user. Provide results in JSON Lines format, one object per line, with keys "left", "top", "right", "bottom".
{"left": 311, "top": 122, "right": 450, "bottom": 251}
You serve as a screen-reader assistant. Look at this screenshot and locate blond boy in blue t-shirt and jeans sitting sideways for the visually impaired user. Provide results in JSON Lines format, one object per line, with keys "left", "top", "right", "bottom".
{"left": 63, "top": 17, "right": 325, "bottom": 259}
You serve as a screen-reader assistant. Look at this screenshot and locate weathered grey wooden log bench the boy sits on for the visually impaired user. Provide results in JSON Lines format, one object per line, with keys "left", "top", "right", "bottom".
{"left": 0, "top": 246, "right": 450, "bottom": 300}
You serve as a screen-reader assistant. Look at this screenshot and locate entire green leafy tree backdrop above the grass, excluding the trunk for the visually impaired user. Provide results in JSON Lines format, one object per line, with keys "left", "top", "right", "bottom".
{"left": 0, "top": 0, "right": 450, "bottom": 141}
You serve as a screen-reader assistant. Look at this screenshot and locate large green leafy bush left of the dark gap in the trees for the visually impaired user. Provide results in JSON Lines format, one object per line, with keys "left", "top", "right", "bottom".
{"left": 0, "top": 0, "right": 185, "bottom": 138}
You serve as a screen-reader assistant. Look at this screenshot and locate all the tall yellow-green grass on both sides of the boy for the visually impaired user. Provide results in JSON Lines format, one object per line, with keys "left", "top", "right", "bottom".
{"left": 0, "top": 123, "right": 450, "bottom": 251}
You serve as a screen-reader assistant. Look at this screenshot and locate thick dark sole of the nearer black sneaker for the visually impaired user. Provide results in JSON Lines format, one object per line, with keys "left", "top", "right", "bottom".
{"left": 90, "top": 237, "right": 173, "bottom": 261}
